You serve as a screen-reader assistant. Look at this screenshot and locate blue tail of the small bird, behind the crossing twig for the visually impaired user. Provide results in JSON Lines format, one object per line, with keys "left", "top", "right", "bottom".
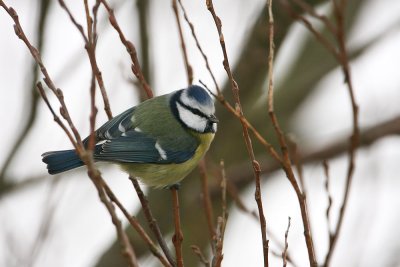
{"left": 42, "top": 150, "right": 84, "bottom": 174}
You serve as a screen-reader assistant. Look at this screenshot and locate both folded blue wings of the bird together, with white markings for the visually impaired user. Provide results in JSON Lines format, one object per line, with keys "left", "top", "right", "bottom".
{"left": 83, "top": 107, "right": 198, "bottom": 164}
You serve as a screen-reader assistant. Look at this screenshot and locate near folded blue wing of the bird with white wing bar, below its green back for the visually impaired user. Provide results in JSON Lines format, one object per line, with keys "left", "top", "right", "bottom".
{"left": 94, "top": 130, "right": 197, "bottom": 164}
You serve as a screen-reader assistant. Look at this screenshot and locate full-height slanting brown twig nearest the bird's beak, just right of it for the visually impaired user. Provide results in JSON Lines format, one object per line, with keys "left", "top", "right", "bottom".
{"left": 206, "top": 0, "right": 268, "bottom": 266}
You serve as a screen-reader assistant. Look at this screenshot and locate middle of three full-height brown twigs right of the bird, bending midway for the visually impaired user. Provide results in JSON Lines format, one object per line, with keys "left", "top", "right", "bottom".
{"left": 267, "top": 0, "right": 317, "bottom": 267}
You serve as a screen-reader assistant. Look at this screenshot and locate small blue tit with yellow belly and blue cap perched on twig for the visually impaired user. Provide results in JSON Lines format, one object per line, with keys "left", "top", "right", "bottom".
{"left": 42, "top": 85, "right": 218, "bottom": 187}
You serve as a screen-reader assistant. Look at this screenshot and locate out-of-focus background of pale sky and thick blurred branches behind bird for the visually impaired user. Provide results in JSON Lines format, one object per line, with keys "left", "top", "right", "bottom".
{"left": 0, "top": 0, "right": 400, "bottom": 267}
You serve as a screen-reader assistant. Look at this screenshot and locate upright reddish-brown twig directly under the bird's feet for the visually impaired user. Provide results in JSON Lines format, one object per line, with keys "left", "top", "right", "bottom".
{"left": 171, "top": 186, "right": 183, "bottom": 267}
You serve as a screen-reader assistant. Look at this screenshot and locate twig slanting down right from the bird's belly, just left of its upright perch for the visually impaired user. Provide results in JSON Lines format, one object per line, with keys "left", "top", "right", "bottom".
{"left": 129, "top": 176, "right": 176, "bottom": 266}
